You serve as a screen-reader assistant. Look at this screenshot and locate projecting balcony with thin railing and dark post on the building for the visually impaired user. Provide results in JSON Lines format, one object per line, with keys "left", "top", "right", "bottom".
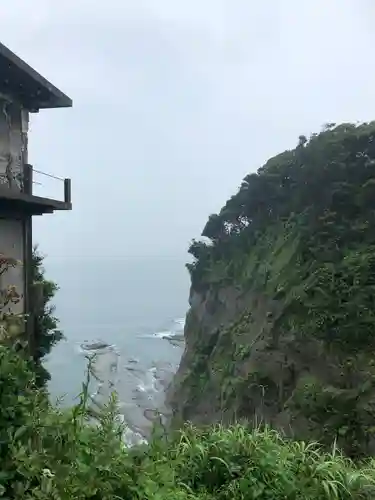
{"left": 0, "top": 164, "right": 72, "bottom": 215}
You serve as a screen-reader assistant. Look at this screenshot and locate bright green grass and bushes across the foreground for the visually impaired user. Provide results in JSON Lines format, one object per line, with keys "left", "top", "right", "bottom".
{"left": 0, "top": 347, "right": 375, "bottom": 500}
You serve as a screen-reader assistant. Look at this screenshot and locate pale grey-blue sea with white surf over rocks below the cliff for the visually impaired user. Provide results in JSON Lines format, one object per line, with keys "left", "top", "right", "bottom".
{"left": 45, "top": 256, "right": 190, "bottom": 446}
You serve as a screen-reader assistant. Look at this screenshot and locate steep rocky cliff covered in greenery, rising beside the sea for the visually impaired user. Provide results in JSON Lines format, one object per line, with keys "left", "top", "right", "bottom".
{"left": 168, "top": 123, "right": 375, "bottom": 456}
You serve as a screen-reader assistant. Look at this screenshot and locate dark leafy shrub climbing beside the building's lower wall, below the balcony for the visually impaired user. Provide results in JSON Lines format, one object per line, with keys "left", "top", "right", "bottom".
{"left": 32, "top": 247, "right": 63, "bottom": 386}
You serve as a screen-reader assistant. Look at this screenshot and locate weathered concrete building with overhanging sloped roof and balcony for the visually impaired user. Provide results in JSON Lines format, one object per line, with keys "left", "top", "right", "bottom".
{"left": 0, "top": 43, "right": 72, "bottom": 350}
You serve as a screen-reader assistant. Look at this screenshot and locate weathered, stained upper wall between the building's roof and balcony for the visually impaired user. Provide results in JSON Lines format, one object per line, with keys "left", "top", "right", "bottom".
{"left": 0, "top": 95, "right": 29, "bottom": 189}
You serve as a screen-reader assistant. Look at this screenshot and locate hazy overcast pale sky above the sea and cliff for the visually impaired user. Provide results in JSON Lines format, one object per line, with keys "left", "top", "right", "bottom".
{"left": 0, "top": 0, "right": 375, "bottom": 257}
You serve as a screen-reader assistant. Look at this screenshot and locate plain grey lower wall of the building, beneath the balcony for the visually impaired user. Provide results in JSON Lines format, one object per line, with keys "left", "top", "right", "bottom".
{"left": 0, "top": 214, "right": 25, "bottom": 314}
